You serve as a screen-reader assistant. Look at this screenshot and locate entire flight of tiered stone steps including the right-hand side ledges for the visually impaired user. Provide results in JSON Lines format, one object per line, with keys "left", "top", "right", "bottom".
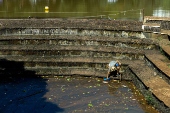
{"left": 0, "top": 19, "right": 170, "bottom": 112}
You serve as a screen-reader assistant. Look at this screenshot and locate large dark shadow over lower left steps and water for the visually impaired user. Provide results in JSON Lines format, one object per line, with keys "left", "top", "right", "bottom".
{"left": 0, "top": 59, "right": 64, "bottom": 113}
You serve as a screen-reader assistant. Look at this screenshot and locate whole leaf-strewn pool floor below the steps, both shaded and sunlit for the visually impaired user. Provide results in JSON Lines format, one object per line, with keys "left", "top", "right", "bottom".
{"left": 0, "top": 76, "right": 157, "bottom": 113}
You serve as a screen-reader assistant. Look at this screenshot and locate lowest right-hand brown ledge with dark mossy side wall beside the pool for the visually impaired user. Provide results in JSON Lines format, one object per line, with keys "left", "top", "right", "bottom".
{"left": 129, "top": 64, "right": 170, "bottom": 113}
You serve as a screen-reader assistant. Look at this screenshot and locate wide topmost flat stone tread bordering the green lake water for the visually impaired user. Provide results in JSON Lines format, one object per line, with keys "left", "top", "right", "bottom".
{"left": 0, "top": 19, "right": 143, "bottom": 31}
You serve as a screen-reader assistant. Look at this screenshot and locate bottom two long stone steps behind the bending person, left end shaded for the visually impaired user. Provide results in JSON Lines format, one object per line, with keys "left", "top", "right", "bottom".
{"left": 0, "top": 56, "right": 143, "bottom": 80}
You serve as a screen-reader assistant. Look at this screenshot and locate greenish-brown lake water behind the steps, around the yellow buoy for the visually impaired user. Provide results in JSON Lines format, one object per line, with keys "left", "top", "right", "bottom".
{"left": 0, "top": 0, "right": 170, "bottom": 20}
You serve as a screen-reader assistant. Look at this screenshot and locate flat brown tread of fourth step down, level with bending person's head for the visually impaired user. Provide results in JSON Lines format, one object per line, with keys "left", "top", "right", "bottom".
{"left": 0, "top": 55, "right": 136, "bottom": 65}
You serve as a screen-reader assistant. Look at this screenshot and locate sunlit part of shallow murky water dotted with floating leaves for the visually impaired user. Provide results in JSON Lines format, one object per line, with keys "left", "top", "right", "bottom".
{"left": 44, "top": 77, "right": 156, "bottom": 113}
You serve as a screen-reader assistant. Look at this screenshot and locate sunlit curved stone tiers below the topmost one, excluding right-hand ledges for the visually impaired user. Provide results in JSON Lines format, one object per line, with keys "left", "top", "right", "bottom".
{"left": 0, "top": 34, "right": 158, "bottom": 79}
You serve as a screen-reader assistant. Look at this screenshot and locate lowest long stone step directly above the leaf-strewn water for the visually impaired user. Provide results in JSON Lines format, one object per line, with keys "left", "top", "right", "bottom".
{"left": 0, "top": 67, "right": 126, "bottom": 80}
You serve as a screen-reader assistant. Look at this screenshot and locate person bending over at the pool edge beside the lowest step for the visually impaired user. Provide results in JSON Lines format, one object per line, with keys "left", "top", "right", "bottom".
{"left": 107, "top": 60, "right": 121, "bottom": 80}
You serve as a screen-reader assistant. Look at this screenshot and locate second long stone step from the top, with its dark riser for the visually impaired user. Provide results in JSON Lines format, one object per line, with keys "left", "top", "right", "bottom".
{"left": 0, "top": 35, "right": 158, "bottom": 49}
